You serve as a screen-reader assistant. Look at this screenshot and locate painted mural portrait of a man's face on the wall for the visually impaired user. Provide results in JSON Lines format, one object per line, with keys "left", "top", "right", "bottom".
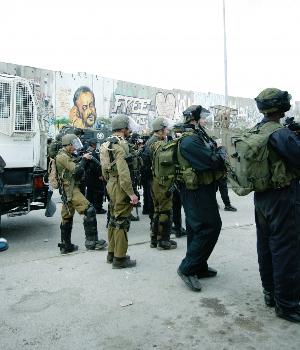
{"left": 69, "top": 86, "right": 97, "bottom": 129}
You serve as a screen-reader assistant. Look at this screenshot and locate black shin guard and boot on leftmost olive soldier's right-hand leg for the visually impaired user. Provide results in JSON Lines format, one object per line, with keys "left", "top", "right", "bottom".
{"left": 83, "top": 206, "right": 107, "bottom": 250}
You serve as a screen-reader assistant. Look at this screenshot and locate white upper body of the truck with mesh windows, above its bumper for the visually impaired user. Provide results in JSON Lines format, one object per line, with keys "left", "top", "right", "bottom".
{"left": 0, "top": 74, "right": 47, "bottom": 169}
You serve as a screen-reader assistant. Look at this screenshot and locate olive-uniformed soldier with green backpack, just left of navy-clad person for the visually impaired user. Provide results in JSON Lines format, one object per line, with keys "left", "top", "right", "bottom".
{"left": 146, "top": 118, "right": 177, "bottom": 250}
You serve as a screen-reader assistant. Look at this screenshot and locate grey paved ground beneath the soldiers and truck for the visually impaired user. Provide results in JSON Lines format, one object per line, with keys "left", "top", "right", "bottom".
{"left": 0, "top": 193, "right": 300, "bottom": 350}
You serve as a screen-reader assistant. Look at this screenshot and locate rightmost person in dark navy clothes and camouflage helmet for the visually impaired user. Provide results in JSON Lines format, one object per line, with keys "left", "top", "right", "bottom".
{"left": 254, "top": 88, "right": 300, "bottom": 323}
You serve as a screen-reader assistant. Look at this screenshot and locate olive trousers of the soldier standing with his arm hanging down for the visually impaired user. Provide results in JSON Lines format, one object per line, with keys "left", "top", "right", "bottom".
{"left": 106, "top": 176, "right": 132, "bottom": 258}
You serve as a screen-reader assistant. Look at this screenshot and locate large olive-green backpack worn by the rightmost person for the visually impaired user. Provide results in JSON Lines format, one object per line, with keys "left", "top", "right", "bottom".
{"left": 226, "top": 122, "right": 282, "bottom": 196}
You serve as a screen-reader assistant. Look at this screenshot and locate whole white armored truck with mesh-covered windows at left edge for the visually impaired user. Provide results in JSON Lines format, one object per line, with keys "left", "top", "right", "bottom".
{"left": 0, "top": 74, "right": 50, "bottom": 230}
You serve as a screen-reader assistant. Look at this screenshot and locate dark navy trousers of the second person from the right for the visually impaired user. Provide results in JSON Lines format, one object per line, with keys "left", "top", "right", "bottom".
{"left": 179, "top": 183, "right": 222, "bottom": 275}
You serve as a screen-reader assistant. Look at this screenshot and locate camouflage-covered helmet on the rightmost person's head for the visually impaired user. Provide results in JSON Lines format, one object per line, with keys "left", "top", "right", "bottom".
{"left": 255, "top": 88, "right": 292, "bottom": 114}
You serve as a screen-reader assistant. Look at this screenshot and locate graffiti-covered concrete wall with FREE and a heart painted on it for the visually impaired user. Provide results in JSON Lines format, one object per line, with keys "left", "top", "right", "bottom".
{"left": 0, "top": 62, "right": 299, "bottom": 152}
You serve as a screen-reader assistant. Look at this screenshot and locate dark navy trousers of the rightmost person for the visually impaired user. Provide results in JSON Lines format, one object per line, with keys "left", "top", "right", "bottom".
{"left": 254, "top": 181, "right": 300, "bottom": 310}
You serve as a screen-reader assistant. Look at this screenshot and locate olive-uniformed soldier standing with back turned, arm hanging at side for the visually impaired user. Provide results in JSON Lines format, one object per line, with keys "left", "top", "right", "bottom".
{"left": 100, "top": 115, "right": 138, "bottom": 269}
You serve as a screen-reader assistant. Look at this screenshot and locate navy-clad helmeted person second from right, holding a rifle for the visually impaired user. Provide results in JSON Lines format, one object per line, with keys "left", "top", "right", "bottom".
{"left": 177, "top": 105, "right": 225, "bottom": 292}
